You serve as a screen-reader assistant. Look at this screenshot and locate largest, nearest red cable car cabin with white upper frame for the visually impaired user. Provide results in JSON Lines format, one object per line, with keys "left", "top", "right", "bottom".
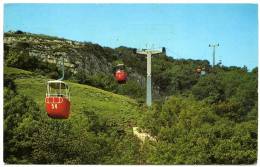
{"left": 45, "top": 80, "right": 70, "bottom": 119}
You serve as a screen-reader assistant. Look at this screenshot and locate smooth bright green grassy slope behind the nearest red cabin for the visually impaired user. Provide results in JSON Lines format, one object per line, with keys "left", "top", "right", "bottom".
{"left": 4, "top": 67, "right": 142, "bottom": 131}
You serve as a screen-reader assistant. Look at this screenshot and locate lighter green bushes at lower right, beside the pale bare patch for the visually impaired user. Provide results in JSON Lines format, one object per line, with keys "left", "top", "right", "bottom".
{"left": 140, "top": 94, "right": 257, "bottom": 164}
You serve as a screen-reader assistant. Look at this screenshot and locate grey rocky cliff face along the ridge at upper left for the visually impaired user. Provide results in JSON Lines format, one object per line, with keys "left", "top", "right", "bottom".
{"left": 4, "top": 33, "right": 117, "bottom": 74}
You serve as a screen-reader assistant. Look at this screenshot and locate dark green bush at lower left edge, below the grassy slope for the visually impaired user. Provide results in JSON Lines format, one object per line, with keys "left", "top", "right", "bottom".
{"left": 4, "top": 88, "right": 40, "bottom": 164}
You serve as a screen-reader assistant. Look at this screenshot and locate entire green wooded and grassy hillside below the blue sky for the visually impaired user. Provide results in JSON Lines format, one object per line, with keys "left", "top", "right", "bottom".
{"left": 4, "top": 31, "right": 258, "bottom": 164}
